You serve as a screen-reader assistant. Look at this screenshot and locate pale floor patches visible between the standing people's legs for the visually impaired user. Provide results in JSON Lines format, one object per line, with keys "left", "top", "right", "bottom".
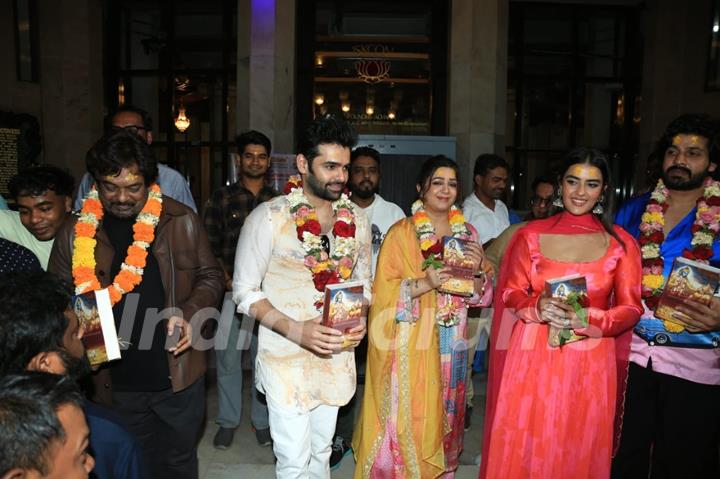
{"left": 199, "top": 370, "right": 486, "bottom": 479}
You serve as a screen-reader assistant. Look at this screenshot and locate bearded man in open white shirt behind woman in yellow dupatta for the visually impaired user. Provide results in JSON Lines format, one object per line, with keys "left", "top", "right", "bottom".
{"left": 330, "top": 146, "right": 405, "bottom": 470}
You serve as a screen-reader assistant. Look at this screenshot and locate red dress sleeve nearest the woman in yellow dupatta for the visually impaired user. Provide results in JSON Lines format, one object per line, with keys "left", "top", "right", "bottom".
{"left": 498, "top": 235, "right": 541, "bottom": 322}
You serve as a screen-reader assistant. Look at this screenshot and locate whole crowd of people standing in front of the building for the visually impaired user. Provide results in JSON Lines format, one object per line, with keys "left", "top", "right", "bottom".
{"left": 0, "top": 106, "right": 720, "bottom": 479}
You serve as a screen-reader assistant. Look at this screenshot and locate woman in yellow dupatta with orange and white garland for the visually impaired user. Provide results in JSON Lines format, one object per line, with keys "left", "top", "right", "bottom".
{"left": 353, "top": 156, "right": 490, "bottom": 478}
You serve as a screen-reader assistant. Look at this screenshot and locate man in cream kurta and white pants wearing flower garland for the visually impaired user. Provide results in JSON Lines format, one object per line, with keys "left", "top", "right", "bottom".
{"left": 233, "top": 118, "right": 371, "bottom": 479}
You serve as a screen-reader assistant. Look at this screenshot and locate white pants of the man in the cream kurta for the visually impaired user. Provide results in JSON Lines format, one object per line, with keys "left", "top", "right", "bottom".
{"left": 267, "top": 396, "right": 339, "bottom": 479}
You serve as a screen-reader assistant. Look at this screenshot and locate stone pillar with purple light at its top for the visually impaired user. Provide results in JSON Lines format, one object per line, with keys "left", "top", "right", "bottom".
{"left": 236, "top": 0, "right": 295, "bottom": 153}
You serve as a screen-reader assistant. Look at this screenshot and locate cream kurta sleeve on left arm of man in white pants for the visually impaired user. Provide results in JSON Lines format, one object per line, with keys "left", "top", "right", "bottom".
{"left": 233, "top": 204, "right": 273, "bottom": 315}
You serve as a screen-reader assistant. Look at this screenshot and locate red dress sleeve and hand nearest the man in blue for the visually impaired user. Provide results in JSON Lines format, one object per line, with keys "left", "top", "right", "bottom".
{"left": 575, "top": 232, "right": 643, "bottom": 337}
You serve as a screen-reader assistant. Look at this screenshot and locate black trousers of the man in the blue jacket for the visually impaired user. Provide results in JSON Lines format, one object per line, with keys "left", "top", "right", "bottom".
{"left": 611, "top": 363, "right": 720, "bottom": 479}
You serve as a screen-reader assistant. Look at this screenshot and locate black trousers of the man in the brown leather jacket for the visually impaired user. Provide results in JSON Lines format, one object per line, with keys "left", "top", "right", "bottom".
{"left": 113, "top": 377, "right": 205, "bottom": 479}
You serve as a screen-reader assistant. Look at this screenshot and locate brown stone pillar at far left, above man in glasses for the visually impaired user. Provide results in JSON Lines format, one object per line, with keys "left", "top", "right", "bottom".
{"left": 36, "top": 0, "right": 103, "bottom": 178}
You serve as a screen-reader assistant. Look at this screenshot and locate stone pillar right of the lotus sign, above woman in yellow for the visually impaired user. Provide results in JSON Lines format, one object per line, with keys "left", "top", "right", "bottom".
{"left": 448, "top": 0, "right": 509, "bottom": 191}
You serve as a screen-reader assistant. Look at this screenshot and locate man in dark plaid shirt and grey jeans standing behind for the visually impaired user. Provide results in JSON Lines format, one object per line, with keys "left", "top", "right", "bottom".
{"left": 205, "top": 130, "right": 279, "bottom": 449}
